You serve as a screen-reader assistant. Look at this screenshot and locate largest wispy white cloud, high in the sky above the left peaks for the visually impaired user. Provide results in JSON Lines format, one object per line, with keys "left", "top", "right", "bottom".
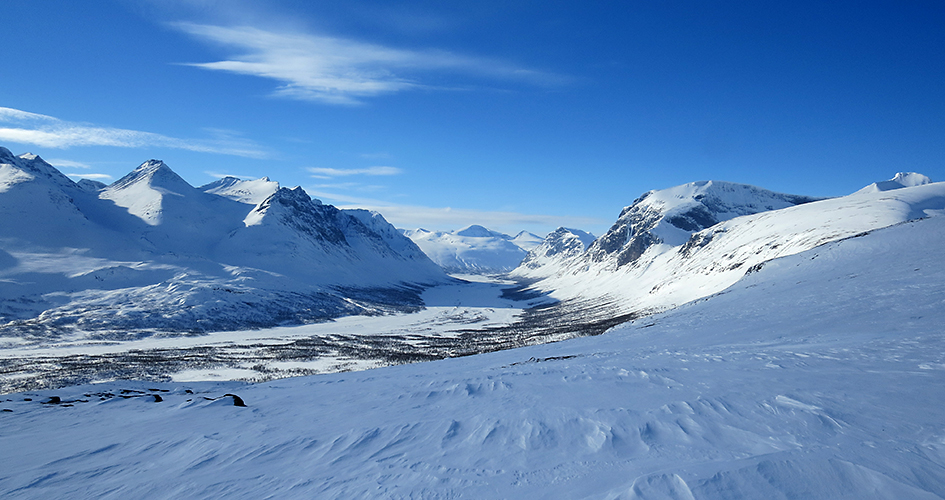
{"left": 173, "top": 22, "right": 568, "bottom": 105}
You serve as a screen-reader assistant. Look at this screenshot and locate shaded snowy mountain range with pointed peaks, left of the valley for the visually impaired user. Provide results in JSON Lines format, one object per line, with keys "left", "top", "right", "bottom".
{"left": 0, "top": 148, "right": 448, "bottom": 335}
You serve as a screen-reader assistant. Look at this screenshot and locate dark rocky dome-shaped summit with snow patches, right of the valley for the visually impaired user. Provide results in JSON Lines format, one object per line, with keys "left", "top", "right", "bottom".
{"left": 588, "top": 181, "right": 818, "bottom": 267}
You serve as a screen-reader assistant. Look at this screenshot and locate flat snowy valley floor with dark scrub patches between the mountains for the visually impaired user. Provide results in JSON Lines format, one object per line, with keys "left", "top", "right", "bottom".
{"left": 0, "top": 275, "right": 548, "bottom": 393}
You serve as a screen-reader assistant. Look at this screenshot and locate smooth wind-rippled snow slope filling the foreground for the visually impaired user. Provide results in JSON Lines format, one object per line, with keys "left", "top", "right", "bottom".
{"left": 0, "top": 214, "right": 945, "bottom": 499}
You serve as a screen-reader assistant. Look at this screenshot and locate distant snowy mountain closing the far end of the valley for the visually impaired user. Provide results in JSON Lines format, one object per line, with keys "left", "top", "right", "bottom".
{"left": 403, "top": 225, "right": 541, "bottom": 273}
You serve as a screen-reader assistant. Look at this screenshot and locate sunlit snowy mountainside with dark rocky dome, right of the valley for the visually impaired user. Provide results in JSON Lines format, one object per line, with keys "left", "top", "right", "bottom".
{"left": 512, "top": 174, "right": 945, "bottom": 314}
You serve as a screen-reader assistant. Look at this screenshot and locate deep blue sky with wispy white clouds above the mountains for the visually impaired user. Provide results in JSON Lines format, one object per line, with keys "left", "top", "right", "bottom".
{"left": 0, "top": 0, "right": 945, "bottom": 234}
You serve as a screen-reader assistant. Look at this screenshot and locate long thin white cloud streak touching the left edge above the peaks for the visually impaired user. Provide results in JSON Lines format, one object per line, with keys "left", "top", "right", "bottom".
{"left": 0, "top": 107, "right": 268, "bottom": 158}
